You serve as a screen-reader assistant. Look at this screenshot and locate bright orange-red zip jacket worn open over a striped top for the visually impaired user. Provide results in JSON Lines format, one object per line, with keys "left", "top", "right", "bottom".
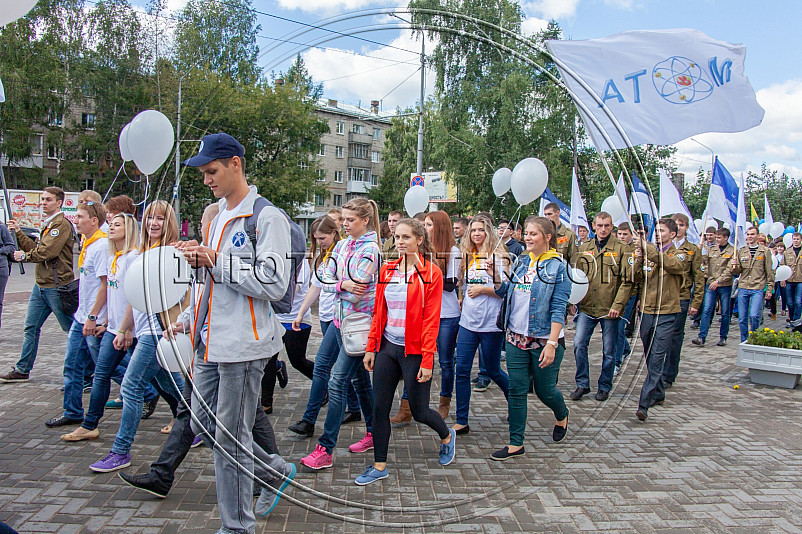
{"left": 366, "top": 258, "right": 443, "bottom": 369}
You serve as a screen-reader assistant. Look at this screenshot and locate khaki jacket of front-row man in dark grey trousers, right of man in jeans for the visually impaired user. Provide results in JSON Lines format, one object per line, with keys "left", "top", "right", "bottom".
{"left": 635, "top": 243, "right": 685, "bottom": 314}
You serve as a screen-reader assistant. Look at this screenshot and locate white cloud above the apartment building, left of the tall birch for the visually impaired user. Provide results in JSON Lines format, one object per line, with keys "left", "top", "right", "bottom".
{"left": 303, "top": 30, "right": 434, "bottom": 111}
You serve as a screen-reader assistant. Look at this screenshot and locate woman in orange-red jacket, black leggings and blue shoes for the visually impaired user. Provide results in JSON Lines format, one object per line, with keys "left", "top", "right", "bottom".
{"left": 356, "top": 219, "right": 456, "bottom": 486}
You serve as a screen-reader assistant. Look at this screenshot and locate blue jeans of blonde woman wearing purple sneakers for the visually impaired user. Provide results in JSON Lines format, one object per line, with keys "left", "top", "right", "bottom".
{"left": 111, "top": 335, "right": 181, "bottom": 454}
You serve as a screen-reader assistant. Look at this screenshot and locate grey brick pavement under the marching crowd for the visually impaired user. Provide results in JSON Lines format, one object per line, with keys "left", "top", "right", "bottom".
{"left": 0, "top": 298, "right": 802, "bottom": 533}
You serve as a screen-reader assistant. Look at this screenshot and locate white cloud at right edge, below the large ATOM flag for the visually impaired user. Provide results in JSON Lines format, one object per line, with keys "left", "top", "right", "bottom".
{"left": 675, "top": 80, "right": 802, "bottom": 178}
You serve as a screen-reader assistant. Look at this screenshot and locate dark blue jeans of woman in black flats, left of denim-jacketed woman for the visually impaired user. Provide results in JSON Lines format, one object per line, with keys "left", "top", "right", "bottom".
{"left": 455, "top": 326, "right": 510, "bottom": 425}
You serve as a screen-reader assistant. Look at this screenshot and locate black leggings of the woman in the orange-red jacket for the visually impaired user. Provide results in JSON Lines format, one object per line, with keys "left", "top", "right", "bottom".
{"left": 373, "top": 338, "right": 449, "bottom": 462}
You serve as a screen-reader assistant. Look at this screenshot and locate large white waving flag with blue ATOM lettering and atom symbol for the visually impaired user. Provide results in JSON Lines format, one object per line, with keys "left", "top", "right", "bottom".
{"left": 546, "top": 29, "right": 764, "bottom": 150}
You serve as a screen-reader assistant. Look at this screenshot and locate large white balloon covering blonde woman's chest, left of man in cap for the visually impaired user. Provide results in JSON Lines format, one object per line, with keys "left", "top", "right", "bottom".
{"left": 123, "top": 247, "right": 190, "bottom": 313}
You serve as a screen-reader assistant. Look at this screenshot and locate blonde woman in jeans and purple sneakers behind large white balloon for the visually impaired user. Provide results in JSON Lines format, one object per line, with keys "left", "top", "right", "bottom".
{"left": 89, "top": 200, "right": 184, "bottom": 473}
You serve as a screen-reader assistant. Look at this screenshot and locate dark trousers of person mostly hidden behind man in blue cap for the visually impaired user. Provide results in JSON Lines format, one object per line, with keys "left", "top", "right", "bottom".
{"left": 150, "top": 362, "right": 278, "bottom": 490}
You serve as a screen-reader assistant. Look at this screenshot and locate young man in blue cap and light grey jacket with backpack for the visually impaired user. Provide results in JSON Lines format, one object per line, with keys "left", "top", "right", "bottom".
{"left": 179, "top": 133, "right": 296, "bottom": 533}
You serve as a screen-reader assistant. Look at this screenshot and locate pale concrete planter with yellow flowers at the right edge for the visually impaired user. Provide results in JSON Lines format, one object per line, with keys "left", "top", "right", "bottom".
{"left": 738, "top": 343, "right": 802, "bottom": 389}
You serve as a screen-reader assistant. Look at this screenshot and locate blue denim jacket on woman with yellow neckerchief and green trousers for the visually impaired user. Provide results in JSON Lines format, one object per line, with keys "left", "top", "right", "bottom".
{"left": 496, "top": 254, "right": 571, "bottom": 338}
